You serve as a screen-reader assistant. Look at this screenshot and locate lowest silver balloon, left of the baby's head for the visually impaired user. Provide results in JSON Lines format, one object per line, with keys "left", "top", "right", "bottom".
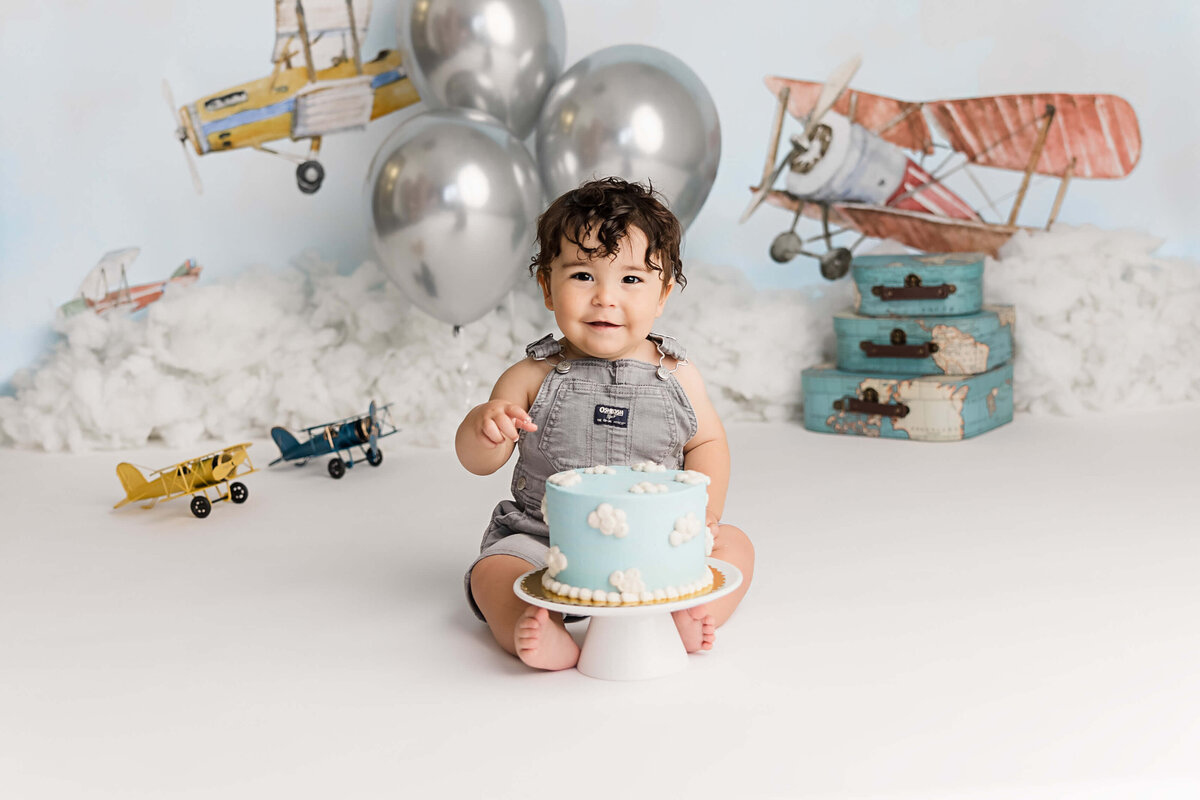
{"left": 366, "top": 109, "right": 542, "bottom": 325}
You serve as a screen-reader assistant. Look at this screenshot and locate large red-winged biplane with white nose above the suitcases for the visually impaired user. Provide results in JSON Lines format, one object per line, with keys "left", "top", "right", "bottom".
{"left": 742, "top": 58, "right": 1141, "bottom": 279}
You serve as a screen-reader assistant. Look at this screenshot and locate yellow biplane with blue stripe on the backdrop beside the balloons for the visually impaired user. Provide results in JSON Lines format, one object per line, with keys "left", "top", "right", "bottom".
{"left": 163, "top": 0, "right": 420, "bottom": 194}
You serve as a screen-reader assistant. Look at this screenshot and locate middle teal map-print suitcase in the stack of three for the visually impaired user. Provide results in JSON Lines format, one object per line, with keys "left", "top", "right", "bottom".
{"left": 833, "top": 306, "right": 1016, "bottom": 375}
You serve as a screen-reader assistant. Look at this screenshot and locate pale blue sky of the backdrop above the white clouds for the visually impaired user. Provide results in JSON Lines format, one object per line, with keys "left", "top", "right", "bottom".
{"left": 0, "top": 0, "right": 1200, "bottom": 385}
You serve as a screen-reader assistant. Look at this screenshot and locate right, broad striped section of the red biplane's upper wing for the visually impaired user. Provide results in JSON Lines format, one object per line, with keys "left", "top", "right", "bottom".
{"left": 925, "top": 94, "right": 1141, "bottom": 178}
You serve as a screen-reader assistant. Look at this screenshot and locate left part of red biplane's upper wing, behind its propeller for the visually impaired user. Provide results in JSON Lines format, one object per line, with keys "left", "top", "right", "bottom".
{"left": 763, "top": 76, "right": 934, "bottom": 154}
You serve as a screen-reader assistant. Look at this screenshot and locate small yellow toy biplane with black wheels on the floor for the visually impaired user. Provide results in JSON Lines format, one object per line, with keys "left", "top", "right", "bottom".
{"left": 113, "top": 441, "right": 254, "bottom": 519}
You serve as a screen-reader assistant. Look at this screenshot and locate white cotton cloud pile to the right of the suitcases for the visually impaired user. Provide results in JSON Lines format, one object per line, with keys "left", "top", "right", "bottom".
{"left": 984, "top": 225, "right": 1200, "bottom": 415}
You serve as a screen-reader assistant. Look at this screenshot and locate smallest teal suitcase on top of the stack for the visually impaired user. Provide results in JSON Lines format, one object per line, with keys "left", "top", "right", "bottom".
{"left": 850, "top": 253, "right": 984, "bottom": 317}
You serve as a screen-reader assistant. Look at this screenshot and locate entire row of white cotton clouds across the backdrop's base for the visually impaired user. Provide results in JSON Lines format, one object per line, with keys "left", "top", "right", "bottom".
{"left": 0, "top": 225, "right": 1200, "bottom": 451}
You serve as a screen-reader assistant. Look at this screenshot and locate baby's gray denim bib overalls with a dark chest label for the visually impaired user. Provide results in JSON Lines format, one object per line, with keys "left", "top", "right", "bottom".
{"left": 464, "top": 333, "right": 697, "bottom": 619}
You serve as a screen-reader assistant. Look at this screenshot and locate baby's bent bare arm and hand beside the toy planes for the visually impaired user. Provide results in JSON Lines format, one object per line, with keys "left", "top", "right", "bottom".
{"left": 455, "top": 359, "right": 541, "bottom": 475}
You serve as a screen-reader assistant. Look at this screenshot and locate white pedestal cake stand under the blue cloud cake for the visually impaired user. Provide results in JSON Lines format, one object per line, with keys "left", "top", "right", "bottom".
{"left": 512, "top": 558, "right": 742, "bottom": 680}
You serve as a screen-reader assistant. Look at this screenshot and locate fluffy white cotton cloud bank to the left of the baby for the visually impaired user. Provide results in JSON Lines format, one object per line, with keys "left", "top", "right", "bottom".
{"left": 0, "top": 253, "right": 554, "bottom": 451}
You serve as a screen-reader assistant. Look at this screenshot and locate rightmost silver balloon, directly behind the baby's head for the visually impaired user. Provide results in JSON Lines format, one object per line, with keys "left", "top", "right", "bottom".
{"left": 538, "top": 44, "right": 721, "bottom": 228}
